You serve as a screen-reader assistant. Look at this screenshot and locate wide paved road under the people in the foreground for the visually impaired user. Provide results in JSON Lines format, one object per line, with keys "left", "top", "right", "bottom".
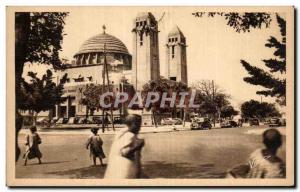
{"left": 16, "top": 127, "right": 285, "bottom": 178}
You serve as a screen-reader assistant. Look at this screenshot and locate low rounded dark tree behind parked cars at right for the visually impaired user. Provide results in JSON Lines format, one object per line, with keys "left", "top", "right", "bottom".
{"left": 241, "top": 100, "right": 280, "bottom": 118}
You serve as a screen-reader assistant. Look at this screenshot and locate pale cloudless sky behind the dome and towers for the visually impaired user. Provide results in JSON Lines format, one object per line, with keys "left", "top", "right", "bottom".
{"left": 24, "top": 7, "right": 280, "bottom": 108}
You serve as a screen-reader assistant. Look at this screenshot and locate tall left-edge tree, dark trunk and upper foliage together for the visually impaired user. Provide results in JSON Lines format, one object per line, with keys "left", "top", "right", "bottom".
{"left": 15, "top": 12, "right": 68, "bottom": 161}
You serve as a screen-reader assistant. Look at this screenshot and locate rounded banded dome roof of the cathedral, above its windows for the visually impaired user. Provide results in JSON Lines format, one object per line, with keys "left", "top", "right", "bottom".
{"left": 74, "top": 33, "right": 130, "bottom": 56}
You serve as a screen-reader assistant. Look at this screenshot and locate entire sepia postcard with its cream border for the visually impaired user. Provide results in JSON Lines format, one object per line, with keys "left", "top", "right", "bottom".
{"left": 6, "top": 6, "right": 296, "bottom": 187}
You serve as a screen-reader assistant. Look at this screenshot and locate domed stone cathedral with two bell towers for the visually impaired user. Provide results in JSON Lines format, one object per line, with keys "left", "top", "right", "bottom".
{"left": 52, "top": 12, "right": 188, "bottom": 118}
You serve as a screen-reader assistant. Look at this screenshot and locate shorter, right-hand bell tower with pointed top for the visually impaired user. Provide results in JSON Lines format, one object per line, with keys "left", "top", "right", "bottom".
{"left": 166, "top": 26, "right": 188, "bottom": 84}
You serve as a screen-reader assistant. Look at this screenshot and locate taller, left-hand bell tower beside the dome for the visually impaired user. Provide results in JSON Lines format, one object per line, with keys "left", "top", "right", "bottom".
{"left": 132, "top": 12, "right": 160, "bottom": 91}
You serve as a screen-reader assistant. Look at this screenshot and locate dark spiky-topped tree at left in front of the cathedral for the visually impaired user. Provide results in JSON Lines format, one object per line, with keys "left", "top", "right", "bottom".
{"left": 19, "top": 70, "right": 67, "bottom": 123}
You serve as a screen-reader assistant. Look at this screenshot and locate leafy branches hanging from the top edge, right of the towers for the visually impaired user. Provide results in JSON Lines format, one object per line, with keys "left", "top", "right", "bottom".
{"left": 192, "top": 12, "right": 272, "bottom": 33}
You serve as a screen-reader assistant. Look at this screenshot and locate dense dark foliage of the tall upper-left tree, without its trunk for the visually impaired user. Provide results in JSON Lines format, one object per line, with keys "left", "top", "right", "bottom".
{"left": 16, "top": 12, "right": 68, "bottom": 68}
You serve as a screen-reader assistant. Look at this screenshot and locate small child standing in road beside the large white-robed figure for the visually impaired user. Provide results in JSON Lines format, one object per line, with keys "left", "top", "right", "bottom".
{"left": 86, "top": 128, "right": 105, "bottom": 166}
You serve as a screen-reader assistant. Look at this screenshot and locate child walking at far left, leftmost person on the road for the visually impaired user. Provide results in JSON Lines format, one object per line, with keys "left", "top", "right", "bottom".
{"left": 24, "top": 126, "right": 42, "bottom": 166}
